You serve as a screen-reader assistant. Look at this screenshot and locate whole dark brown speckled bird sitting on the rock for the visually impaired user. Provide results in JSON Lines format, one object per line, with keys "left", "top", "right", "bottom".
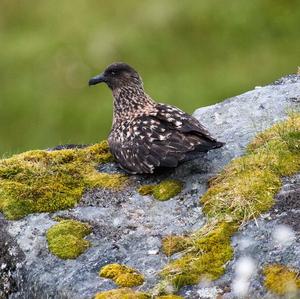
{"left": 89, "top": 63, "right": 224, "bottom": 174}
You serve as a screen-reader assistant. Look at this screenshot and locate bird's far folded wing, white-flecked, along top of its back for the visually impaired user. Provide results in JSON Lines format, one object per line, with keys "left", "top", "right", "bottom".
{"left": 156, "top": 104, "right": 216, "bottom": 142}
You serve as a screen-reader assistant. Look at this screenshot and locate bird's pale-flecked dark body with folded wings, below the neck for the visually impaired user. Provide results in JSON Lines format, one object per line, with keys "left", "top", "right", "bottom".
{"left": 109, "top": 104, "right": 223, "bottom": 173}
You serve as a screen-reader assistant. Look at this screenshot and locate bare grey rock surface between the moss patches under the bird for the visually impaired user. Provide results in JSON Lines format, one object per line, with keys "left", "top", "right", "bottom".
{"left": 0, "top": 75, "right": 300, "bottom": 299}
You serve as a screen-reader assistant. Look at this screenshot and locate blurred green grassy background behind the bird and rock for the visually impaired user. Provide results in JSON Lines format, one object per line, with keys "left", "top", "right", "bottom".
{"left": 0, "top": 0, "right": 300, "bottom": 155}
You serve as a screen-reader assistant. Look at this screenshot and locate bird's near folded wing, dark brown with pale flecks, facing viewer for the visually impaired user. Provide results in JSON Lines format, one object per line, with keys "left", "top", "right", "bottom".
{"left": 109, "top": 115, "right": 198, "bottom": 173}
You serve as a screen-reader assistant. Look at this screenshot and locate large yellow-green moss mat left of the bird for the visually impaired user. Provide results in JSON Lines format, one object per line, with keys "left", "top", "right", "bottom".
{"left": 0, "top": 141, "right": 127, "bottom": 219}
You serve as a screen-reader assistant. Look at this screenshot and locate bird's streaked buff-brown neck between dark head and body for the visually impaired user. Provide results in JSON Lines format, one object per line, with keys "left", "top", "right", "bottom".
{"left": 113, "top": 86, "right": 155, "bottom": 122}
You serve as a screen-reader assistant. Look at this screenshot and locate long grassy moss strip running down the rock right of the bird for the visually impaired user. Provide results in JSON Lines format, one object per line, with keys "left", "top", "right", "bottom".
{"left": 161, "top": 113, "right": 300, "bottom": 289}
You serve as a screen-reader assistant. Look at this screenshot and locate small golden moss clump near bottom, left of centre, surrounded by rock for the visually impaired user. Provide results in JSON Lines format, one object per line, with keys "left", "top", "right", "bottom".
{"left": 99, "top": 264, "right": 144, "bottom": 287}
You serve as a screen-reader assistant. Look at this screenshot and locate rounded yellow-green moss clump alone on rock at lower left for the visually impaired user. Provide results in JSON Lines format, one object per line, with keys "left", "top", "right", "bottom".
{"left": 47, "top": 220, "right": 91, "bottom": 259}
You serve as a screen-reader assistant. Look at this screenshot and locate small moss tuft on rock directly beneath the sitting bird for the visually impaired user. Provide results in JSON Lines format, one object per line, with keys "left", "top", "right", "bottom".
{"left": 138, "top": 179, "right": 183, "bottom": 201}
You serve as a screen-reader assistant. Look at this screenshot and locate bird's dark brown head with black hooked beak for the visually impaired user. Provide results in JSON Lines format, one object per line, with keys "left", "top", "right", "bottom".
{"left": 89, "top": 62, "right": 143, "bottom": 90}
